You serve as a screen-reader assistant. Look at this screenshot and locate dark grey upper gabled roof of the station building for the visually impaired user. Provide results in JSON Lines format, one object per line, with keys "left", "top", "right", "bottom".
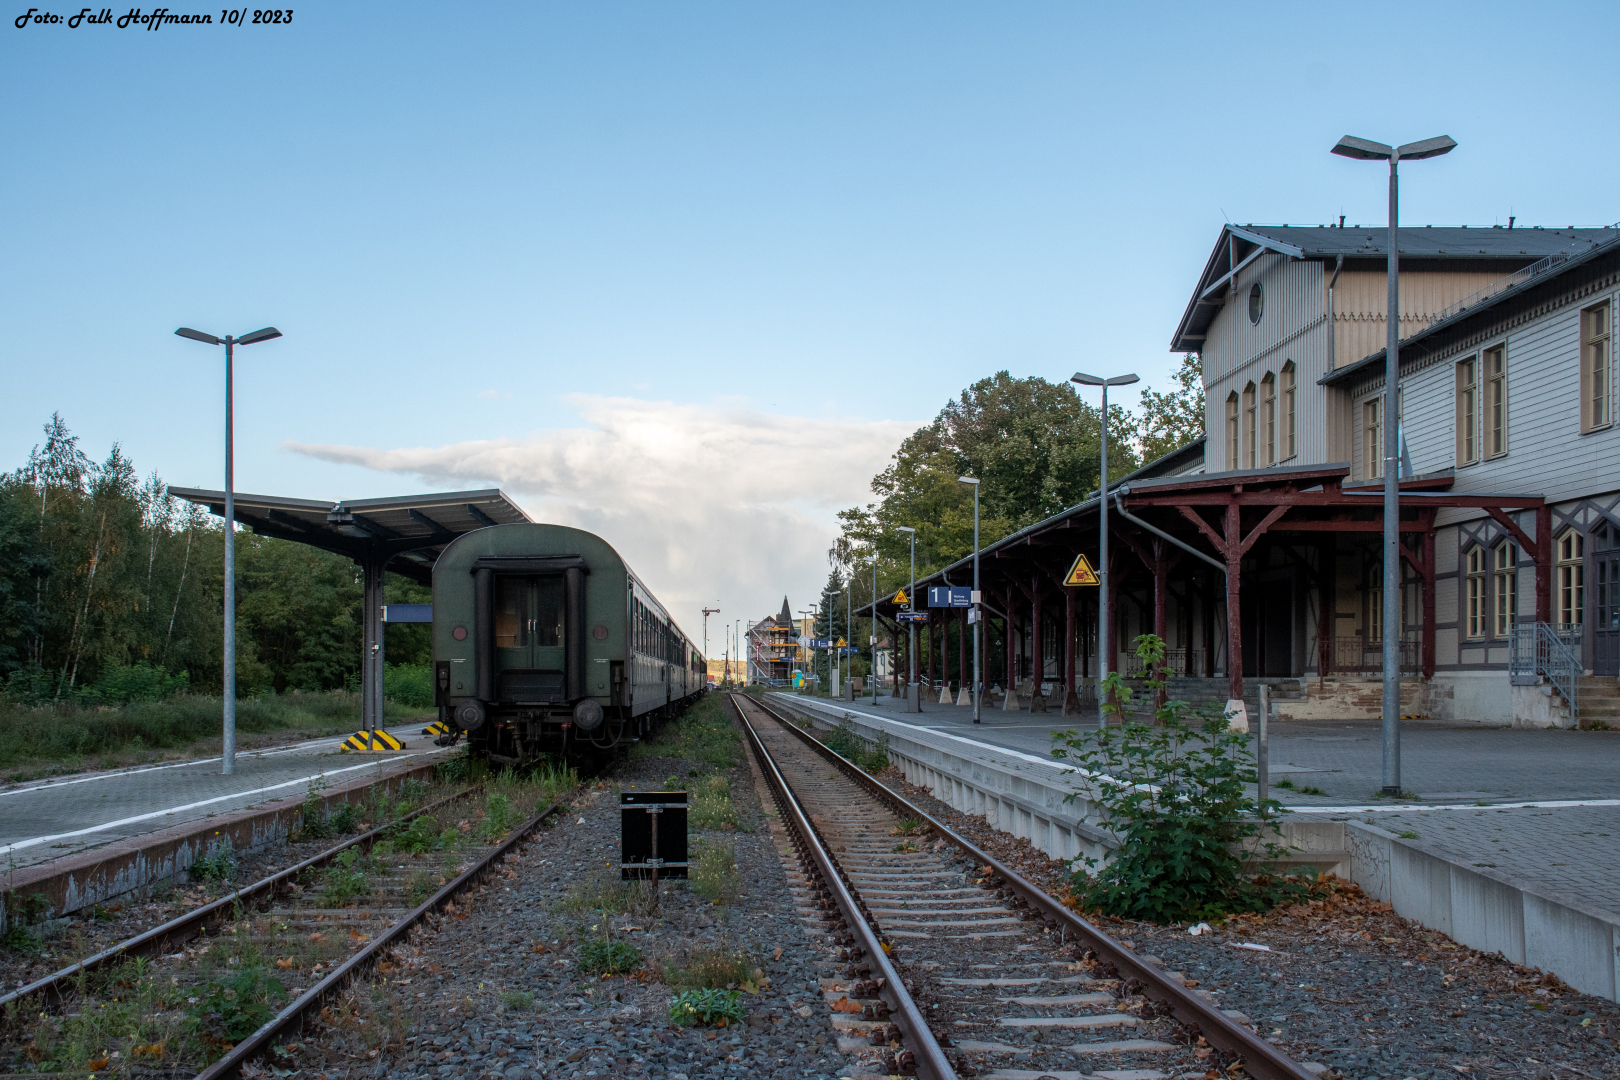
{"left": 1170, "top": 223, "right": 1615, "bottom": 353}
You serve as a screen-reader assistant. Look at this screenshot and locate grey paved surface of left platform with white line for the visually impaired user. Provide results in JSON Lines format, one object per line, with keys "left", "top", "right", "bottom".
{"left": 0, "top": 721, "right": 441, "bottom": 868}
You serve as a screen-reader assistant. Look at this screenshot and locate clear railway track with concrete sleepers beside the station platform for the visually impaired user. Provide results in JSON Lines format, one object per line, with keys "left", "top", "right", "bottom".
{"left": 731, "top": 695, "right": 1312, "bottom": 1080}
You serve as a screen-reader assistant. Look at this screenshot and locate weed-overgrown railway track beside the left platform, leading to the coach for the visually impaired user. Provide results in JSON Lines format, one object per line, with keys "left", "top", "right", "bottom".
{"left": 0, "top": 787, "right": 564, "bottom": 1080}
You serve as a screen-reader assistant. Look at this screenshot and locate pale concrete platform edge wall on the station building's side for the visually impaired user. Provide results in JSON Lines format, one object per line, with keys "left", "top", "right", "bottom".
{"left": 770, "top": 695, "right": 1620, "bottom": 1001}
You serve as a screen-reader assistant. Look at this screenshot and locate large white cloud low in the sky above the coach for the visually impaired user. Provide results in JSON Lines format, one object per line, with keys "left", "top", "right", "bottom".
{"left": 285, "top": 395, "right": 917, "bottom": 653}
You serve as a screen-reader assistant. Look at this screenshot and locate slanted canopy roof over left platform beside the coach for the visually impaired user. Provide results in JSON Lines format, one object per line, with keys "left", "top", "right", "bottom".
{"left": 168, "top": 487, "right": 531, "bottom": 585}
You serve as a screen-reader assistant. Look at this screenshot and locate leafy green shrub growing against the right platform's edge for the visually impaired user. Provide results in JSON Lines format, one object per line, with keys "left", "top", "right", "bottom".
{"left": 1053, "top": 635, "right": 1286, "bottom": 923}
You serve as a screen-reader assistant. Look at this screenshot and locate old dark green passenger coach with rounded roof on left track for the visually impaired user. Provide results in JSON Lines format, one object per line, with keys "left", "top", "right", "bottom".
{"left": 433, "top": 525, "right": 708, "bottom": 766}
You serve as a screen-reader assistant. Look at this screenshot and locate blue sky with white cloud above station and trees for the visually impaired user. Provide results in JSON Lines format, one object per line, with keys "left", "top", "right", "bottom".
{"left": 0, "top": 2, "right": 1620, "bottom": 628}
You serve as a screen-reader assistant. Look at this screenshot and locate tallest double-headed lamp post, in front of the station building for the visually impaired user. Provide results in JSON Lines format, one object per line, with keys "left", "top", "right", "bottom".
{"left": 1333, "top": 134, "right": 1456, "bottom": 795}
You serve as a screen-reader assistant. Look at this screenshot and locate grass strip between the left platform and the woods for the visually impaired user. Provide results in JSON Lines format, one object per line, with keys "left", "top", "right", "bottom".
{"left": 0, "top": 690, "right": 424, "bottom": 782}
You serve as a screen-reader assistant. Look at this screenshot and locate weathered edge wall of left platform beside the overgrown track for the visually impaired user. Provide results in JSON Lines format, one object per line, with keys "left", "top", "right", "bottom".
{"left": 0, "top": 756, "right": 439, "bottom": 933}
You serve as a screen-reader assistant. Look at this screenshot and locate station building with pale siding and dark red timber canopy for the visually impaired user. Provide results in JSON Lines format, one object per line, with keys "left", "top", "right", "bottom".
{"left": 876, "top": 225, "right": 1620, "bottom": 725}
